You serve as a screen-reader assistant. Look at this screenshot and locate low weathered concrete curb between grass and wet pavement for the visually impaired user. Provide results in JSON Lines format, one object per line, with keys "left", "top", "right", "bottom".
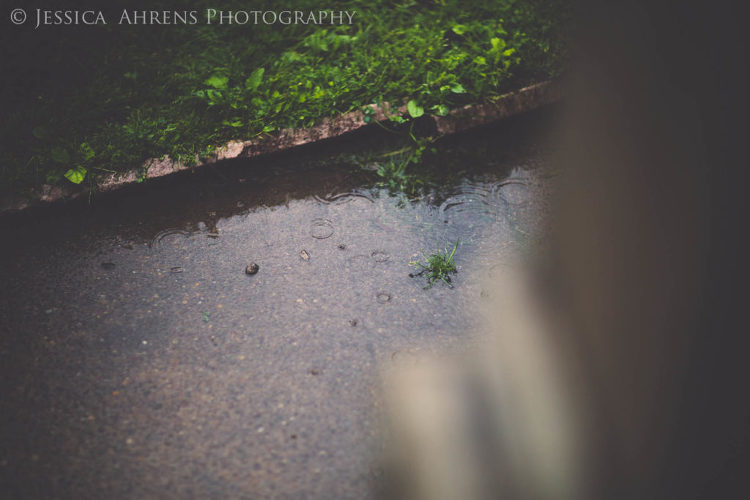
{"left": 0, "top": 81, "right": 561, "bottom": 214}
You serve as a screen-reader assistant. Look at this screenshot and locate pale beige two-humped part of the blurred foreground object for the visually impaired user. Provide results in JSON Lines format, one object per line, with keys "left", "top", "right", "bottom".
{"left": 386, "top": 268, "right": 583, "bottom": 500}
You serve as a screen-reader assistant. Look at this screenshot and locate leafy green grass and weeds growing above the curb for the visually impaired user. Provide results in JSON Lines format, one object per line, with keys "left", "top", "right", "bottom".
{"left": 0, "top": 0, "right": 569, "bottom": 192}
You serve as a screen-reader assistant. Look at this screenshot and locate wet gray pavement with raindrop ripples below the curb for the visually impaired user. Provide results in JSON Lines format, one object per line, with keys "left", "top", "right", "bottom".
{"left": 0, "top": 108, "right": 560, "bottom": 498}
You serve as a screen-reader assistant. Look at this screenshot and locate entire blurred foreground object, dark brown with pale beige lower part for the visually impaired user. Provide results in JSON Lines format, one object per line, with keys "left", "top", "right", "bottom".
{"left": 387, "top": 2, "right": 750, "bottom": 499}
